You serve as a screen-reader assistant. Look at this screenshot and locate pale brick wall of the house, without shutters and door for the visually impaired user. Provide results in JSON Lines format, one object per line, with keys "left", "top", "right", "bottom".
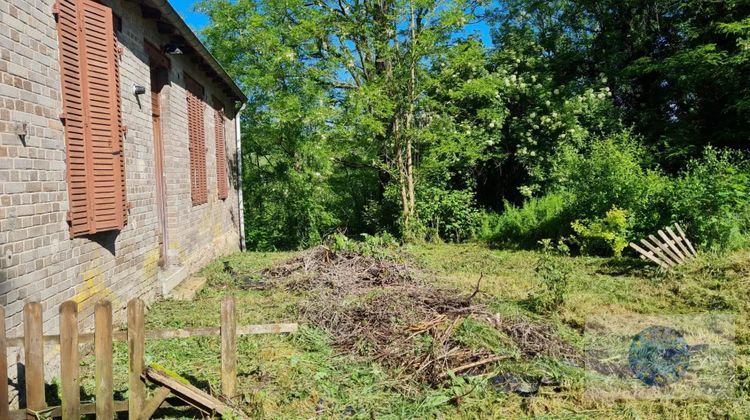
{"left": 0, "top": 0, "right": 239, "bottom": 344}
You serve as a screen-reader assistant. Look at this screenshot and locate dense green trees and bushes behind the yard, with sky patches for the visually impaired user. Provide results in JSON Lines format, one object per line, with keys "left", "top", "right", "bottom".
{"left": 198, "top": 0, "right": 750, "bottom": 255}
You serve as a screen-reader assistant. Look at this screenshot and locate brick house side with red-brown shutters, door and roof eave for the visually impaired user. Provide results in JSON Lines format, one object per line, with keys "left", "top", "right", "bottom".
{"left": 0, "top": 0, "right": 246, "bottom": 336}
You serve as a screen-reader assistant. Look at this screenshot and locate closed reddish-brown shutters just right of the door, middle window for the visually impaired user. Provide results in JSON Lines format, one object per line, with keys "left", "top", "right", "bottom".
{"left": 185, "top": 74, "right": 208, "bottom": 206}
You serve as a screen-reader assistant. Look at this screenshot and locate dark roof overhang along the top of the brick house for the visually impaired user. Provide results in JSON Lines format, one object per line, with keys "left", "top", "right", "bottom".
{"left": 140, "top": 0, "right": 247, "bottom": 104}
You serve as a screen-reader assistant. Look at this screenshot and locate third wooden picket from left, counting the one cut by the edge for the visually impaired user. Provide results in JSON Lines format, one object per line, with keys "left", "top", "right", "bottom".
{"left": 60, "top": 300, "right": 81, "bottom": 420}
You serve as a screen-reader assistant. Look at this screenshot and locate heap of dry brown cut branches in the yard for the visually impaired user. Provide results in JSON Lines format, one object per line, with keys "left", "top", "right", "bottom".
{"left": 263, "top": 246, "right": 576, "bottom": 383}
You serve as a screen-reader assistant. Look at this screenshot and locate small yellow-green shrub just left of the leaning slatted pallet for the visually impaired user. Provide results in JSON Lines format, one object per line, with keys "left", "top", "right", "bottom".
{"left": 571, "top": 207, "right": 629, "bottom": 258}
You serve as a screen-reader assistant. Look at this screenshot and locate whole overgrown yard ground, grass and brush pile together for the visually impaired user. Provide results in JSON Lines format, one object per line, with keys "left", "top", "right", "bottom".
{"left": 82, "top": 244, "right": 750, "bottom": 419}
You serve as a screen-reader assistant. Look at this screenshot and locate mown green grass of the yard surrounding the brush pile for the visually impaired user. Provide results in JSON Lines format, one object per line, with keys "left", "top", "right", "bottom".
{"left": 78, "top": 244, "right": 750, "bottom": 418}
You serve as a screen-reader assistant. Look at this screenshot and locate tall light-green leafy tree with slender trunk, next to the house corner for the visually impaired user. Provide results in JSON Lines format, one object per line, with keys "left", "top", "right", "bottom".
{"left": 199, "top": 0, "right": 484, "bottom": 246}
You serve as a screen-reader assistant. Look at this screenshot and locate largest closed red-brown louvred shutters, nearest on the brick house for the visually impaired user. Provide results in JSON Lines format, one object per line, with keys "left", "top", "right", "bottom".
{"left": 55, "top": 0, "right": 127, "bottom": 236}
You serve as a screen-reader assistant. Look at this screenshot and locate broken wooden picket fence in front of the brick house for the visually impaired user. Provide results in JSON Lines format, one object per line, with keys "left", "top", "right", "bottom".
{"left": 0, "top": 296, "right": 297, "bottom": 419}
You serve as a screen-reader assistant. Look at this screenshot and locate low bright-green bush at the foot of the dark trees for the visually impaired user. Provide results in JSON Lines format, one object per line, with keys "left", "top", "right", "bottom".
{"left": 483, "top": 193, "right": 574, "bottom": 248}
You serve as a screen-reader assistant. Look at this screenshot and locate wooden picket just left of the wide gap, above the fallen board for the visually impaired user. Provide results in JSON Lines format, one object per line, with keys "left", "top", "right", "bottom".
{"left": 128, "top": 299, "right": 146, "bottom": 419}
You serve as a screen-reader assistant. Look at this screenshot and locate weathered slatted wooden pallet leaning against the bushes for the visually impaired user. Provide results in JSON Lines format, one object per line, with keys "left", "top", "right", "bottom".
{"left": 630, "top": 223, "right": 698, "bottom": 269}
